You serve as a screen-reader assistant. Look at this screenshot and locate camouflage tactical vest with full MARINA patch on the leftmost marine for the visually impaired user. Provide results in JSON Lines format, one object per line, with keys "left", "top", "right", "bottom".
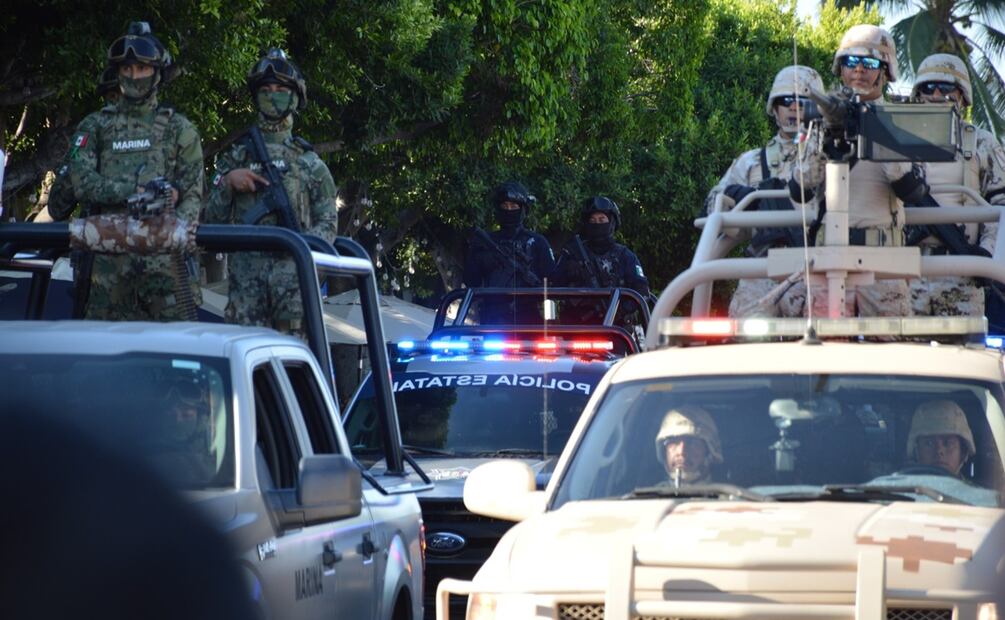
{"left": 97, "top": 101, "right": 178, "bottom": 210}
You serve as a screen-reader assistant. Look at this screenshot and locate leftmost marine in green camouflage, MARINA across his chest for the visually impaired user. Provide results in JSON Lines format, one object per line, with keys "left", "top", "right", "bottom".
{"left": 69, "top": 22, "right": 203, "bottom": 321}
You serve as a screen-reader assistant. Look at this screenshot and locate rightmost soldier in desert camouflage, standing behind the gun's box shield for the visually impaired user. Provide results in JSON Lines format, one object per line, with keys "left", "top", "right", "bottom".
{"left": 909, "top": 54, "right": 1005, "bottom": 317}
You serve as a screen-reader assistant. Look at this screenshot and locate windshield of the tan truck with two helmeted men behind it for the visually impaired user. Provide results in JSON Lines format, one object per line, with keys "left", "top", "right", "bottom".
{"left": 553, "top": 375, "right": 1005, "bottom": 507}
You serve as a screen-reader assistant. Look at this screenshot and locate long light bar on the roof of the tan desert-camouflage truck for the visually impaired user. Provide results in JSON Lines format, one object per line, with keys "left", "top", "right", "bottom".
{"left": 659, "top": 317, "right": 987, "bottom": 344}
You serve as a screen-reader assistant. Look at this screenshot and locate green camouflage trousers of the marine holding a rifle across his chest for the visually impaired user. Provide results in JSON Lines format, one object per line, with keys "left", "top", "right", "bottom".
{"left": 225, "top": 253, "right": 305, "bottom": 338}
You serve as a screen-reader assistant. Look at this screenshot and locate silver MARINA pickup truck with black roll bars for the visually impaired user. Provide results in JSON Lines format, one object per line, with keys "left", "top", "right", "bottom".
{"left": 0, "top": 224, "right": 429, "bottom": 620}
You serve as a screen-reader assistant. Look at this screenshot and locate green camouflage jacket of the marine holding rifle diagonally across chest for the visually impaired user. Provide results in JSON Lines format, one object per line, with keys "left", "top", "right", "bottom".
{"left": 205, "top": 125, "right": 339, "bottom": 241}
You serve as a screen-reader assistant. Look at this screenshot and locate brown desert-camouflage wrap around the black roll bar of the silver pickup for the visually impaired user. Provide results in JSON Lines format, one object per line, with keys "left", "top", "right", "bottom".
{"left": 69, "top": 213, "right": 198, "bottom": 255}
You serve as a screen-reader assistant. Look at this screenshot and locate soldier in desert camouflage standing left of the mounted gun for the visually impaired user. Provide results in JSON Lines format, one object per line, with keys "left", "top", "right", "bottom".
{"left": 705, "top": 65, "right": 823, "bottom": 317}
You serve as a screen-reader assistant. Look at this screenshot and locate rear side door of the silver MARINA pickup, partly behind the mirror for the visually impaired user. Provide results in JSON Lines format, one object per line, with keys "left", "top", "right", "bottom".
{"left": 282, "top": 350, "right": 377, "bottom": 620}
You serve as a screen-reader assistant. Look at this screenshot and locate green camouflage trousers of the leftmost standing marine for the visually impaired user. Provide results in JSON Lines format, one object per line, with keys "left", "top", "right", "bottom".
{"left": 84, "top": 254, "right": 202, "bottom": 321}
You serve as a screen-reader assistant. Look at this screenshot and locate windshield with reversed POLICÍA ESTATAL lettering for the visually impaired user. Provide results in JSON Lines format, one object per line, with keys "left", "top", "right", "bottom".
{"left": 346, "top": 366, "right": 606, "bottom": 464}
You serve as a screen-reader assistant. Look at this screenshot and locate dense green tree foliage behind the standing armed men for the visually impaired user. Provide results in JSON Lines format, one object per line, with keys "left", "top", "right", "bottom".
{"left": 0, "top": 0, "right": 878, "bottom": 305}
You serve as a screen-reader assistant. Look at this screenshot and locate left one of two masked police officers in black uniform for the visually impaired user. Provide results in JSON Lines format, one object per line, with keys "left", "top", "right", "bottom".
{"left": 463, "top": 181, "right": 555, "bottom": 287}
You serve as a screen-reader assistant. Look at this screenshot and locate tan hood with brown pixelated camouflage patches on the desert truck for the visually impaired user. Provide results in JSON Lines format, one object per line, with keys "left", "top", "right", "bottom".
{"left": 488, "top": 499, "right": 1005, "bottom": 592}
